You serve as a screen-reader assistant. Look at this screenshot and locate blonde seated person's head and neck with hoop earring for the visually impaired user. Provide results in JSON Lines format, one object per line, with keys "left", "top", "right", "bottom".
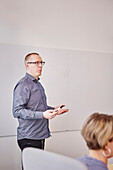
{"left": 81, "top": 113, "right": 113, "bottom": 168}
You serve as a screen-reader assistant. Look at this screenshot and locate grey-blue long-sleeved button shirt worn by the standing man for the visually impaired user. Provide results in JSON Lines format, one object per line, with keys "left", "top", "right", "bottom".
{"left": 13, "top": 73, "right": 54, "bottom": 140}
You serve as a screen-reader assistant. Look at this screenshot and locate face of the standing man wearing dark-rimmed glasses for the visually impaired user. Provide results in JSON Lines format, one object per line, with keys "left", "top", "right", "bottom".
{"left": 26, "top": 54, "right": 42, "bottom": 79}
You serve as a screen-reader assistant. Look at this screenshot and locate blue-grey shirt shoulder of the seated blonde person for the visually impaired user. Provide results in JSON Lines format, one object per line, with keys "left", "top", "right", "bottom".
{"left": 78, "top": 155, "right": 108, "bottom": 170}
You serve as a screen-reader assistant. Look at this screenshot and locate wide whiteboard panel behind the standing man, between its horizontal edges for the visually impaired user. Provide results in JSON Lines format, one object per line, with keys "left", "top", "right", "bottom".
{"left": 0, "top": 44, "right": 113, "bottom": 136}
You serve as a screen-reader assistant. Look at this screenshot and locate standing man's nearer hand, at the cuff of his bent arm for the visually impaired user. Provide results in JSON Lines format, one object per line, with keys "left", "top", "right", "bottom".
{"left": 43, "top": 110, "right": 57, "bottom": 119}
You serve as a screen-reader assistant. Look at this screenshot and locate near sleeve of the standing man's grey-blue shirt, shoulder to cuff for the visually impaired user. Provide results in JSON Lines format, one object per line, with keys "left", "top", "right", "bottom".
{"left": 13, "top": 83, "right": 43, "bottom": 119}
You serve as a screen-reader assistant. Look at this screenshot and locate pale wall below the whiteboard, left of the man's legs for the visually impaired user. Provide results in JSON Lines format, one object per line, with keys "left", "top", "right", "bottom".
{"left": 0, "top": 136, "right": 21, "bottom": 170}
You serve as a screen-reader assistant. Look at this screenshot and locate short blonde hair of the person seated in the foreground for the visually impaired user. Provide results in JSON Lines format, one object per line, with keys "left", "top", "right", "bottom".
{"left": 81, "top": 113, "right": 113, "bottom": 150}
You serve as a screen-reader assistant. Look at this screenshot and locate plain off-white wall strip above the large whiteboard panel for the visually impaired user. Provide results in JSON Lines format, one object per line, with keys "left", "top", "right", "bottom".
{"left": 0, "top": 0, "right": 113, "bottom": 52}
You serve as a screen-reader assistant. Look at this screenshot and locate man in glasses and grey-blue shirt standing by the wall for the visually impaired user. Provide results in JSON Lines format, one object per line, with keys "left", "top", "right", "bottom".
{"left": 13, "top": 53, "right": 68, "bottom": 150}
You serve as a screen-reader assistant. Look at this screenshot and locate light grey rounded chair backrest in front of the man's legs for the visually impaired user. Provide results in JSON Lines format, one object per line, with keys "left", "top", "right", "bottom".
{"left": 22, "top": 148, "right": 87, "bottom": 170}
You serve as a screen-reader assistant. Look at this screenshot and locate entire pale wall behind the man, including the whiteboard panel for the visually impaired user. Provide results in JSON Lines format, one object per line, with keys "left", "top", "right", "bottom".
{"left": 0, "top": 0, "right": 113, "bottom": 170}
